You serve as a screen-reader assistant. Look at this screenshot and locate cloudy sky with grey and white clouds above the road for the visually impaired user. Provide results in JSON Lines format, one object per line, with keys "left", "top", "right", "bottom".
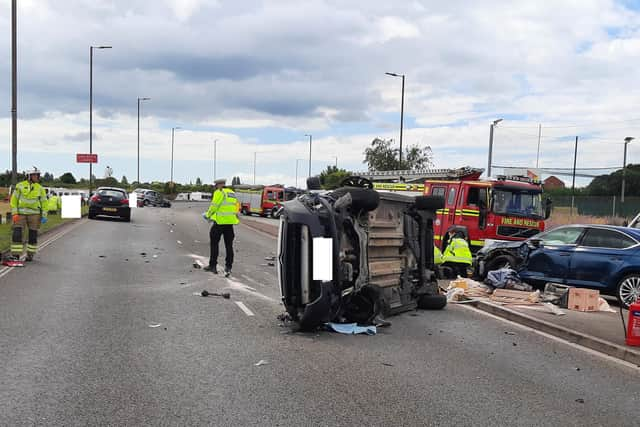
{"left": 0, "top": 0, "right": 640, "bottom": 185}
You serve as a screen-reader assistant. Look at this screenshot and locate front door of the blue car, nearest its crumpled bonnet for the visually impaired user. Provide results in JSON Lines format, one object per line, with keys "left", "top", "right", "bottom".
{"left": 520, "top": 226, "right": 584, "bottom": 283}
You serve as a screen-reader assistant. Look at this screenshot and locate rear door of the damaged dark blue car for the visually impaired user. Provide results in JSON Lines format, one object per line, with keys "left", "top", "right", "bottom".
{"left": 567, "top": 227, "right": 638, "bottom": 288}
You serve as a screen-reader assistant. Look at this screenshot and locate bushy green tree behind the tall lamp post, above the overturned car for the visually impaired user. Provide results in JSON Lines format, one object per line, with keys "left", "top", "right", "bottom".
{"left": 363, "top": 138, "right": 433, "bottom": 171}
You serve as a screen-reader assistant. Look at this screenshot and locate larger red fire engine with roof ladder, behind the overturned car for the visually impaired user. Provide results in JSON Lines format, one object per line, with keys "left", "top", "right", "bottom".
{"left": 359, "top": 167, "right": 551, "bottom": 252}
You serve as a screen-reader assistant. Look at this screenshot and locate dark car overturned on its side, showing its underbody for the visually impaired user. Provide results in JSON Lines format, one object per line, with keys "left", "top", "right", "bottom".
{"left": 277, "top": 177, "right": 446, "bottom": 329}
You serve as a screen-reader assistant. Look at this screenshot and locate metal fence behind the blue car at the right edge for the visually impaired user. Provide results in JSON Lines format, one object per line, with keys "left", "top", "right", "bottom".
{"left": 553, "top": 196, "right": 640, "bottom": 219}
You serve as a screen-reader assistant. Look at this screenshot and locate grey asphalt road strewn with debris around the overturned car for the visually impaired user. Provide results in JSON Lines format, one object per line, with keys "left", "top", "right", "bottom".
{"left": 0, "top": 204, "right": 640, "bottom": 426}
